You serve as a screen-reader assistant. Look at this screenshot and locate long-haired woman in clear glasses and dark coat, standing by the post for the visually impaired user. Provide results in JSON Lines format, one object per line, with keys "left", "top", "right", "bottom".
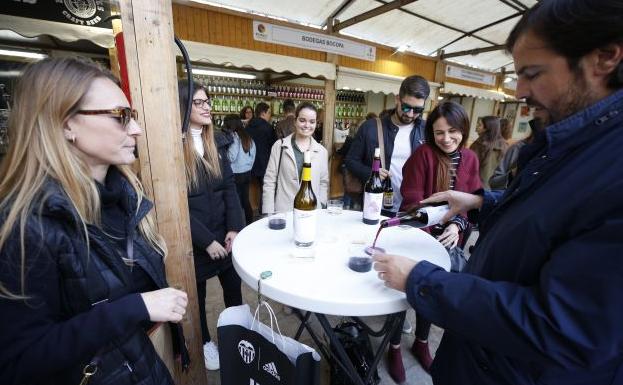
{"left": 179, "top": 80, "right": 245, "bottom": 370}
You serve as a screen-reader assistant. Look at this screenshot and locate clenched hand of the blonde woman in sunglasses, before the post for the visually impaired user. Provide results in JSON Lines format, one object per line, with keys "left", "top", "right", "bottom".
{"left": 141, "top": 287, "right": 188, "bottom": 323}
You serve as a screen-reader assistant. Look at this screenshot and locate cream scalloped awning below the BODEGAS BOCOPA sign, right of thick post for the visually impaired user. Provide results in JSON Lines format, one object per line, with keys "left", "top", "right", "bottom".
{"left": 183, "top": 40, "right": 335, "bottom": 80}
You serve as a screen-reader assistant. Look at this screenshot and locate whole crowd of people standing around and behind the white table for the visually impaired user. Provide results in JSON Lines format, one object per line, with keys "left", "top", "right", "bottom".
{"left": 0, "top": 0, "right": 623, "bottom": 385}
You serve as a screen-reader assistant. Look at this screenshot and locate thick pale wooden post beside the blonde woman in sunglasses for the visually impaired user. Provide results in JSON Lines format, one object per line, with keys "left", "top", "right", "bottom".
{"left": 120, "top": 0, "right": 207, "bottom": 385}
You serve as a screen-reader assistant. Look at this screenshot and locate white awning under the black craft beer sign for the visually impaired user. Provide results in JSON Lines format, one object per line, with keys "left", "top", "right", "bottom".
{"left": 0, "top": 14, "right": 115, "bottom": 48}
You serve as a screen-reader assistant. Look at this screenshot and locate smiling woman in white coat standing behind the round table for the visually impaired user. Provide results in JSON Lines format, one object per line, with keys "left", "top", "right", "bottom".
{"left": 262, "top": 102, "right": 329, "bottom": 214}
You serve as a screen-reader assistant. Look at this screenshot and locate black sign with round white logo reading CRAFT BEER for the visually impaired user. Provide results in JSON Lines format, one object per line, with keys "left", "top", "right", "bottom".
{"left": 0, "top": 0, "right": 112, "bottom": 28}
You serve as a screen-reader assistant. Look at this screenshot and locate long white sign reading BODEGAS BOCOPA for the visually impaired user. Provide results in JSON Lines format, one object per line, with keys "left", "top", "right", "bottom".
{"left": 253, "top": 20, "right": 376, "bottom": 61}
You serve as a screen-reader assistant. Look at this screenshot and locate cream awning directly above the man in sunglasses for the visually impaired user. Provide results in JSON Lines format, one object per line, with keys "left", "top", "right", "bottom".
{"left": 335, "top": 66, "right": 439, "bottom": 94}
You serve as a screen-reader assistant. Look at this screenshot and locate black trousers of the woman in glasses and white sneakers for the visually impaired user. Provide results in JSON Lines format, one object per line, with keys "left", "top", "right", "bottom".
{"left": 197, "top": 264, "right": 242, "bottom": 344}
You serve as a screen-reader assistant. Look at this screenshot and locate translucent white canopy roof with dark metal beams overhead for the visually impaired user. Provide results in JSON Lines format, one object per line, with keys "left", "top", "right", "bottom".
{"left": 184, "top": 0, "right": 537, "bottom": 72}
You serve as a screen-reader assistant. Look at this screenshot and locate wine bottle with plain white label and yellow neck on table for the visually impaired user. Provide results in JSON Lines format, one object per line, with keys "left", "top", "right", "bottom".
{"left": 294, "top": 151, "right": 318, "bottom": 247}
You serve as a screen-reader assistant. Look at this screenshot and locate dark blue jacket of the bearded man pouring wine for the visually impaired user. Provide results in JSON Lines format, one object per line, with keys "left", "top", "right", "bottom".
{"left": 407, "top": 90, "right": 623, "bottom": 385}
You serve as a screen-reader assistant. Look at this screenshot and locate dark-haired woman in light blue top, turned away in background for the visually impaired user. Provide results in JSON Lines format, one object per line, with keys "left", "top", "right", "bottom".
{"left": 223, "top": 114, "right": 255, "bottom": 224}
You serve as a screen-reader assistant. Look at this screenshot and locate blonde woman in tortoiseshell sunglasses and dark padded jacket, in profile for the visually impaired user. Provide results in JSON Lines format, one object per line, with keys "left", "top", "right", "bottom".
{"left": 0, "top": 58, "right": 187, "bottom": 385}
